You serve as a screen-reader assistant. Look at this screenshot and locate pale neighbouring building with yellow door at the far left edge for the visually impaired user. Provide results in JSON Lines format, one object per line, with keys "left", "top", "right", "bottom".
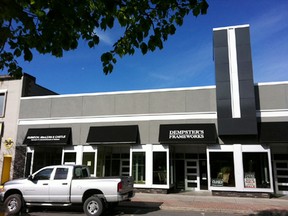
{"left": 0, "top": 74, "right": 56, "bottom": 184}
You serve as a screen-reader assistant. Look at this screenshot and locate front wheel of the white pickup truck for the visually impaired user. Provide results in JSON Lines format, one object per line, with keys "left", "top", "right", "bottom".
{"left": 4, "top": 194, "right": 22, "bottom": 215}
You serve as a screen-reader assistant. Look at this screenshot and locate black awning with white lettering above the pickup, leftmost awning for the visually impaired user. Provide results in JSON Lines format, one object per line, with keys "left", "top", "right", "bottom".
{"left": 23, "top": 128, "right": 71, "bottom": 145}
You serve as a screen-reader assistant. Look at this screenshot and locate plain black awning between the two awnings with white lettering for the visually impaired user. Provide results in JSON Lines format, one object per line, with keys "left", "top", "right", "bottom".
{"left": 87, "top": 125, "right": 139, "bottom": 144}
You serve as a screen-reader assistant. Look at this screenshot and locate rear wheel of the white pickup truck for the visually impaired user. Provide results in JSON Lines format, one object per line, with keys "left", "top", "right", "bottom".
{"left": 83, "top": 195, "right": 103, "bottom": 216}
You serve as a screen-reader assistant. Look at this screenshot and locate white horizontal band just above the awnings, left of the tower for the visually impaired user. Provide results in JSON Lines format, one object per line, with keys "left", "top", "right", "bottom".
{"left": 18, "top": 112, "right": 217, "bottom": 125}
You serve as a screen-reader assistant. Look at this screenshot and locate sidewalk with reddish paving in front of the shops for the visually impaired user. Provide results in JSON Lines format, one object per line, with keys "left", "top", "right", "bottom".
{"left": 120, "top": 192, "right": 288, "bottom": 216}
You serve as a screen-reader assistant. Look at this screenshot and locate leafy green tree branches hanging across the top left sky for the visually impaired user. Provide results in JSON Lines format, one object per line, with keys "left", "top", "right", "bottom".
{"left": 0, "top": 0, "right": 208, "bottom": 77}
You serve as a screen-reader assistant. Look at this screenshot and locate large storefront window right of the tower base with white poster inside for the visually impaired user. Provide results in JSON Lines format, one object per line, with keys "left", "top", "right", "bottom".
{"left": 243, "top": 152, "right": 270, "bottom": 188}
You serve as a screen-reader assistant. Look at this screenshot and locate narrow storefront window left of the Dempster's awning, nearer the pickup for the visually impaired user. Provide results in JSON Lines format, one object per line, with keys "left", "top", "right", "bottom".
{"left": 132, "top": 152, "right": 145, "bottom": 184}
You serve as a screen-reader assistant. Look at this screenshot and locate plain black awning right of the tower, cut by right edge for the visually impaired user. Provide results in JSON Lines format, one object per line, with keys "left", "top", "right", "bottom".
{"left": 258, "top": 122, "right": 288, "bottom": 143}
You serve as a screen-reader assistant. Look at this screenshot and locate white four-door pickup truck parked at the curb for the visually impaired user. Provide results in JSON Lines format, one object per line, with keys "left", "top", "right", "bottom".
{"left": 0, "top": 165, "right": 134, "bottom": 216}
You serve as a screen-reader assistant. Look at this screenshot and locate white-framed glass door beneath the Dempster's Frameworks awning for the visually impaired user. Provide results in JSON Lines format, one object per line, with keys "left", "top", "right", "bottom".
{"left": 185, "top": 160, "right": 200, "bottom": 190}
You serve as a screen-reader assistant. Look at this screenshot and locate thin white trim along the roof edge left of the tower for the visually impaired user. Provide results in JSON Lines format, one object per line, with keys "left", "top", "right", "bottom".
{"left": 21, "top": 85, "right": 216, "bottom": 100}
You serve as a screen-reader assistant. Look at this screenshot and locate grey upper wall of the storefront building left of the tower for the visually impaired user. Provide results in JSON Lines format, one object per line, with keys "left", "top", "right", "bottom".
{"left": 18, "top": 87, "right": 216, "bottom": 145}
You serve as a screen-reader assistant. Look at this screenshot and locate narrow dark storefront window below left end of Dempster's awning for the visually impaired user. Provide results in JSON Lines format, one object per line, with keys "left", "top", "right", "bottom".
{"left": 153, "top": 152, "right": 167, "bottom": 184}
